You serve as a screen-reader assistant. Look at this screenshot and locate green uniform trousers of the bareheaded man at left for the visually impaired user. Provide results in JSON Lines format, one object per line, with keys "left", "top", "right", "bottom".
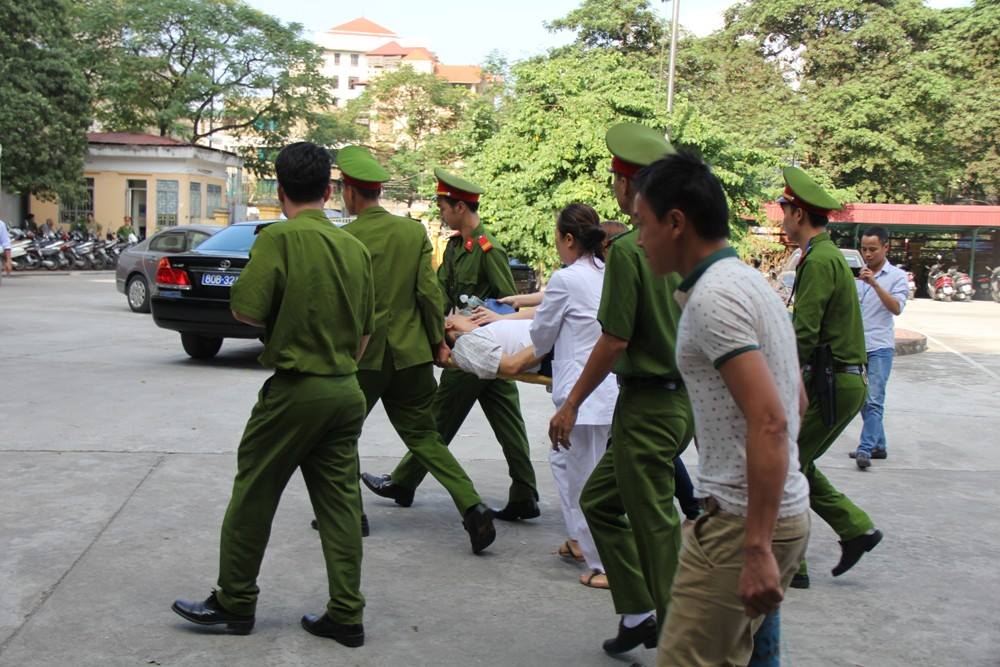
{"left": 217, "top": 373, "right": 365, "bottom": 623}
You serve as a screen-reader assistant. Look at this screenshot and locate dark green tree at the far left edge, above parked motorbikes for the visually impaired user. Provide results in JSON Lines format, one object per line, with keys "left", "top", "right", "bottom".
{"left": 0, "top": 0, "right": 90, "bottom": 200}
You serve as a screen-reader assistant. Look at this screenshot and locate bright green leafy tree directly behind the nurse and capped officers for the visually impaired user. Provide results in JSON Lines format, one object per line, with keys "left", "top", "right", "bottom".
{"left": 468, "top": 49, "right": 775, "bottom": 272}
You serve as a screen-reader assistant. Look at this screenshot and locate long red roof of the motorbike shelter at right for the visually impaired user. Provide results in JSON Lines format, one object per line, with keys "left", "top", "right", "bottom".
{"left": 764, "top": 202, "right": 1000, "bottom": 227}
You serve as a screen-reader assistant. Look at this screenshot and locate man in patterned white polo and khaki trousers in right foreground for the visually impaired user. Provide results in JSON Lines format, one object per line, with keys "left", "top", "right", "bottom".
{"left": 635, "top": 151, "right": 809, "bottom": 667}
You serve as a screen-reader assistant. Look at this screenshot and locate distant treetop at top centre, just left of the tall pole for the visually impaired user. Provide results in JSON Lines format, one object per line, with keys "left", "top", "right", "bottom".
{"left": 545, "top": 0, "right": 665, "bottom": 53}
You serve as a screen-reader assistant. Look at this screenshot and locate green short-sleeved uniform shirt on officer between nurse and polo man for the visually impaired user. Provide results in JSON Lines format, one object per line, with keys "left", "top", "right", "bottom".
{"left": 597, "top": 229, "right": 681, "bottom": 379}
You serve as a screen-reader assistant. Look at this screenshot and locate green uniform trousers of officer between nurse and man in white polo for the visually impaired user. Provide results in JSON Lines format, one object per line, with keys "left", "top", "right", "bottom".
{"left": 580, "top": 386, "right": 693, "bottom": 624}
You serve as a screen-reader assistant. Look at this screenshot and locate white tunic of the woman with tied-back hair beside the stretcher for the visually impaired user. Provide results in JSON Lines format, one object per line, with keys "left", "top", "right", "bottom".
{"left": 531, "top": 256, "right": 618, "bottom": 425}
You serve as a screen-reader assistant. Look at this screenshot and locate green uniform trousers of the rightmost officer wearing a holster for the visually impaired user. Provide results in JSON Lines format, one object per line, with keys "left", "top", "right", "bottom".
{"left": 799, "top": 373, "right": 875, "bottom": 540}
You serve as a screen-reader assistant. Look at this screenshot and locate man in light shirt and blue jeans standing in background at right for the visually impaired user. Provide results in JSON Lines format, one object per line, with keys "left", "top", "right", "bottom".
{"left": 851, "top": 227, "right": 910, "bottom": 470}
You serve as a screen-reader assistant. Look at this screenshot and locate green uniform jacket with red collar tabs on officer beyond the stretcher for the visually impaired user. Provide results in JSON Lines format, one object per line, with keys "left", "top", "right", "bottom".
{"left": 438, "top": 224, "right": 517, "bottom": 314}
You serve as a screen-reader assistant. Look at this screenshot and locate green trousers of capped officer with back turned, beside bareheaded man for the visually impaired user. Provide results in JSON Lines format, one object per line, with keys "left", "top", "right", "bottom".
{"left": 358, "top": 346, "right": 482, "bottom": 515}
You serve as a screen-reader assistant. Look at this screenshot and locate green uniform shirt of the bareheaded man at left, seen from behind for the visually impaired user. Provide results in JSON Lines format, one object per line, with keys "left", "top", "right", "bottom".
{"left": 230, "top": 209, "right": 375, "bottom": 375}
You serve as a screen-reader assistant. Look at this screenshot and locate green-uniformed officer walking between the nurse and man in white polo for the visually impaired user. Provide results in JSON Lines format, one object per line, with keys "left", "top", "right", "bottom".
{"left": 549, "top": 123, "right": 694, "bottom": 654}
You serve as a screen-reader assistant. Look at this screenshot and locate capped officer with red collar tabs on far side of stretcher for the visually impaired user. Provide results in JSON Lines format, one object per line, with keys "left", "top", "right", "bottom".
{"left": 362, "top": 168, "right": 539, "bottom": 521}
